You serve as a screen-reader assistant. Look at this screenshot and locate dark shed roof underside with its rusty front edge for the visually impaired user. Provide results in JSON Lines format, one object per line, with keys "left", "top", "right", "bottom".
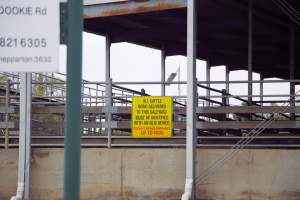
{"left": 85, "top": 0, "right": 300, "bottom": 78}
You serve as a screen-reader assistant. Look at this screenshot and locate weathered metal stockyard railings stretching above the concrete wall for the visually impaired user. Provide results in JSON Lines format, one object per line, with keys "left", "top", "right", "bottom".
{"left": 0, "top": 74, "right": 300, "bottom": 148}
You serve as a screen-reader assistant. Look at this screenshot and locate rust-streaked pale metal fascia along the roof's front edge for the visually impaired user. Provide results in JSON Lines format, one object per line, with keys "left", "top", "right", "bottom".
{"left": 84, "top": 0, "right": 186, "bottom": 19}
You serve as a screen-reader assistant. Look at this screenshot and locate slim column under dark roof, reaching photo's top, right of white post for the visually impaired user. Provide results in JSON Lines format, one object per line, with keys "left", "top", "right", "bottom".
{"left": 248, "top": 0, "right": 253, "bottom": 105}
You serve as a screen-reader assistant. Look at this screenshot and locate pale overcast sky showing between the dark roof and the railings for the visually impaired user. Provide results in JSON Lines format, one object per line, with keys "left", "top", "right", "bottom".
{"left": 60, "top": 33, "right": 288, "bottom": 104}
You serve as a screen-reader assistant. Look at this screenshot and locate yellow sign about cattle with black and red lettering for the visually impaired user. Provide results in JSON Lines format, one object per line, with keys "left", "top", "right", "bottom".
{"left": 131, "top": 96, "right": 173, "bottom": 138}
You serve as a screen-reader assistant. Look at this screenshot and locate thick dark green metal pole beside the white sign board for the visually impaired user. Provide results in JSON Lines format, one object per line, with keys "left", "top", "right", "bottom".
{"left": 64, "top": 0, "right": 83, "bottom": 200}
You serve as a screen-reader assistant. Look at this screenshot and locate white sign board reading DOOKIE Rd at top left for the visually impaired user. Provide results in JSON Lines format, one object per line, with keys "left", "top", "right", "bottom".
{"left": 0, "top": 0, "right": 60, "bottom": 72}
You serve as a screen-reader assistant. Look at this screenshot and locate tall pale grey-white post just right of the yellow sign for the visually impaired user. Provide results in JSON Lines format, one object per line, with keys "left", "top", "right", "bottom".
{"left": 182, "top": 0, "right": 197, "bottom": 200}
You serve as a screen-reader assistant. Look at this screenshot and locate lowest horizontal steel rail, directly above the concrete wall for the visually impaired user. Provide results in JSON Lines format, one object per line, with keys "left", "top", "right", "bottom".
{"left": 0, "top": 136, "right": 300, "bottom": 148}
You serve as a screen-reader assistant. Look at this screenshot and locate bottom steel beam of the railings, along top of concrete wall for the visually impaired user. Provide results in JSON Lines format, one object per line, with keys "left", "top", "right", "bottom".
{"left": 9, "top": 135, "right": 300, "bottom": 148}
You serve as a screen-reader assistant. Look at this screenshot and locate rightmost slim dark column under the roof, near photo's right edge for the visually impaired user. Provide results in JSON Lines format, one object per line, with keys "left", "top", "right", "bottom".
{"left": 290, "top": 20, "right": 295, "bottom": 119}
